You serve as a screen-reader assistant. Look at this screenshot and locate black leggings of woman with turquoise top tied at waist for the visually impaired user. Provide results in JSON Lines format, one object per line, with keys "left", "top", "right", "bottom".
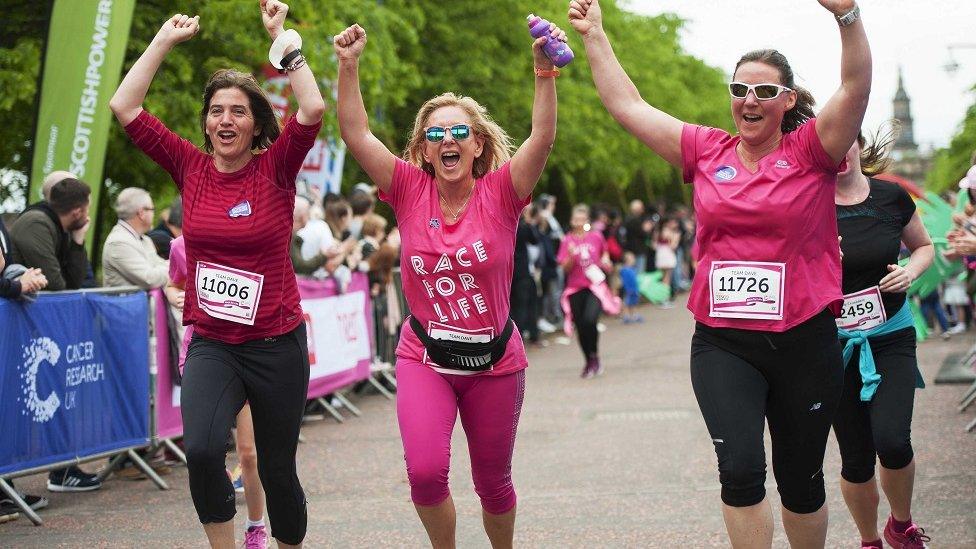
{"left": 834, "top": 328, "right": 917, "bottom": 483}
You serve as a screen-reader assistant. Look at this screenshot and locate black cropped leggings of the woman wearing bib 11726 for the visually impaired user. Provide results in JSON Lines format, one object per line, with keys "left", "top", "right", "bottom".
{"left": 691, "top": 311, "right": 844, "bottom": 513}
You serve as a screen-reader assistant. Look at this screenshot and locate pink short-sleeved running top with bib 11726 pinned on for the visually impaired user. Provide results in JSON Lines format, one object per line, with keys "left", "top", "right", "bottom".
{"left": 681, "top": 119, "right": 844, "bottom": 332}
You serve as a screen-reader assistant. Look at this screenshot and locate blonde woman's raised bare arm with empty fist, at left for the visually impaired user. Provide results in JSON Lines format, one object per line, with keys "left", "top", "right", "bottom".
{"left": 333, "top": 25, "right": 396, "bottom": 192}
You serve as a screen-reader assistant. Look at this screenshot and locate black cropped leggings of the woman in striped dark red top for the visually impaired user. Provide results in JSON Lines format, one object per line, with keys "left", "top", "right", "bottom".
{"left": 181, "top": 323, "right": 309, "bottom": 545}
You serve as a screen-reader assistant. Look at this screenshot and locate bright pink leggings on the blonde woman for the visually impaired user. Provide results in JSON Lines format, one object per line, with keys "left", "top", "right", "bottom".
{"left": 396, "top": 358, "right": 525, "bottom": 515}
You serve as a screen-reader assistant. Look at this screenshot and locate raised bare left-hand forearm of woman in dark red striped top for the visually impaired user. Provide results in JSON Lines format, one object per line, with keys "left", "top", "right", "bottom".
{"left": 108, "top": 13, "right": 200, "bottom": 126}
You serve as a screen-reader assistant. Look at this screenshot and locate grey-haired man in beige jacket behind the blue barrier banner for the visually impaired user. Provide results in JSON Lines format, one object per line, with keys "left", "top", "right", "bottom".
{"left": 102, "top": 187, "right": 169, "bottom": 290}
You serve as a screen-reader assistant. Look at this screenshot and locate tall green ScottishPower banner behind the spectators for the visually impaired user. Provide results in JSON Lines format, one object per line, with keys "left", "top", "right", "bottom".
{"left": 29, "top": 0, "right": 135, "bottom": 209}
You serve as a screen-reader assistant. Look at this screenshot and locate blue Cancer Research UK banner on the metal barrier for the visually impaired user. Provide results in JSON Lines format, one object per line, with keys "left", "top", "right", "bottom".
{"left": 0, "top": 292, "right": 149, "bottom": 474}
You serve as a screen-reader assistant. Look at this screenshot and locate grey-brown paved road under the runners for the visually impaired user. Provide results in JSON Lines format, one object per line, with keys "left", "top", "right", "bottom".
{"left": 0, "top": 298, "right": 976, "bottom": 548}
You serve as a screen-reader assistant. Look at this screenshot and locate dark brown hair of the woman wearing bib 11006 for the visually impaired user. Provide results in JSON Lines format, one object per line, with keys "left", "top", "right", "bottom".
{"left": 200, "top": 69, "right": 281, "bottom": 153}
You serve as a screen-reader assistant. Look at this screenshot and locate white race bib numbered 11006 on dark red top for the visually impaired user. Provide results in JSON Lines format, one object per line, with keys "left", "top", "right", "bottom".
{"left": 196, "top": 261, "right": 264, "bottom": 326}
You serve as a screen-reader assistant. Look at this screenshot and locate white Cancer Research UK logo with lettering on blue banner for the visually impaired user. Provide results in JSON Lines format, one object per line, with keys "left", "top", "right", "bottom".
{"left": 17, "top": 337, "right": 105, "bottom": 423}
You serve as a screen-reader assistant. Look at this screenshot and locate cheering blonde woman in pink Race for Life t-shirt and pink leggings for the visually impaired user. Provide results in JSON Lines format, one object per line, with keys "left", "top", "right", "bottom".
{"left": 335, "top": 19, "right": 565, "bottom": 547}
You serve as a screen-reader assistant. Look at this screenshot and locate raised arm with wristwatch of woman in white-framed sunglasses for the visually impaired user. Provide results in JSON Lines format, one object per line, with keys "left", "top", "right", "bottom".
{"left": 817, "top": 0, "right": 871, "bottom": 164}
